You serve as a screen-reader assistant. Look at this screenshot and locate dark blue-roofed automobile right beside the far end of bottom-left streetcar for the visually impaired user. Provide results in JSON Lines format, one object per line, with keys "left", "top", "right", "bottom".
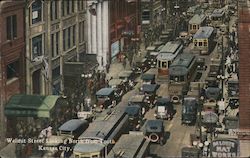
{"left": 125, "top": 105, "right": 142, "bottom": 131}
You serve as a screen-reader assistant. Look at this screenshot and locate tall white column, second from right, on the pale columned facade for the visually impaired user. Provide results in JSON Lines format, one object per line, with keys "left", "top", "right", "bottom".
{"left": 97, "top": 2, "right": 103, "bottom": 70}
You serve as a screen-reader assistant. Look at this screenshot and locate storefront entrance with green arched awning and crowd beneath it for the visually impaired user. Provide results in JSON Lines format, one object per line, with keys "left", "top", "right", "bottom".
{"left": 4, "top": 95, "right": 71, "bottom": 138}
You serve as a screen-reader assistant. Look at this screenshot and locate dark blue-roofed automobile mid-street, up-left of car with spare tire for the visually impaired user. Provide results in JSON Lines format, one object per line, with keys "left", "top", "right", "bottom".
{"left": 140, "top": 84, "right": 159, "bottom": 108}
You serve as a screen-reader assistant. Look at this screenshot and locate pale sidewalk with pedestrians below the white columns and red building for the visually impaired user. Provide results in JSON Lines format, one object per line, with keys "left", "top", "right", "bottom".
{"left": 106, "top": 43, "right": 146, "bottom": 80}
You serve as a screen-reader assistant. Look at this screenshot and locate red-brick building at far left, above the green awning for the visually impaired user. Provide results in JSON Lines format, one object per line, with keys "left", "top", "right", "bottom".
{"left": 0, "top": 0, "right": 25, "bottom": 148}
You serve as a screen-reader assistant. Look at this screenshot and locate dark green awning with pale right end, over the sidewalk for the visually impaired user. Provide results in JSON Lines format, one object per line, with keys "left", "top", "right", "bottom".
{"left": 4, "top": 95, "right": 59, "bottom": 118}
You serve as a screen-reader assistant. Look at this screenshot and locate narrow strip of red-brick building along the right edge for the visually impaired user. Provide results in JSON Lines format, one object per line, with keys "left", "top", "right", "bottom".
{"left": 238, "top": 0, "right": 250, "bottom": 140}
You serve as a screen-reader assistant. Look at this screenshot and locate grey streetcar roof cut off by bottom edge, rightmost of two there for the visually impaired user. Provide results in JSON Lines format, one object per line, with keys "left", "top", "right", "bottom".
{"left": 108, "top": 131, "right": 150, "bottom": 158}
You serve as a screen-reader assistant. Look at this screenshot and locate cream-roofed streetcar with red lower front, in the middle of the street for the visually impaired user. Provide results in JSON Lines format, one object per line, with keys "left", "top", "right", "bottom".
{"left": 156, "top": 41, "right": 183, "bottom": 77}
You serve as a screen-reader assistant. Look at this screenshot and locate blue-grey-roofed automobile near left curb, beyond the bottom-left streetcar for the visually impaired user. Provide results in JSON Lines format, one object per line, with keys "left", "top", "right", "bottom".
{"left": 95, "top": 88, "right": 121, "bottom": 112}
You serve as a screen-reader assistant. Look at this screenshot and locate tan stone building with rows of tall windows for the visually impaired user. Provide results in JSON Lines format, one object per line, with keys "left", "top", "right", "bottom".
{"left": 25, "top": 0, "right": 87, "bottom": 95}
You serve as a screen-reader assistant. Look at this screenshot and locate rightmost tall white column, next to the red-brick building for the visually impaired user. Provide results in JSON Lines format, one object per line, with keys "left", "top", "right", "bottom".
{"left": 102, "top": 1, "right": 110, "bottom": 67}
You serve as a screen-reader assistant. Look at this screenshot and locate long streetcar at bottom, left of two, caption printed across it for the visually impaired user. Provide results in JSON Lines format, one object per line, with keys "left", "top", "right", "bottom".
{"left": 73, "top": 106, "right": 129, "bottom": 158}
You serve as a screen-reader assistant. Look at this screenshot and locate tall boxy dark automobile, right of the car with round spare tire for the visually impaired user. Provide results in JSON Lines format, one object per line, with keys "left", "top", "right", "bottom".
{"left": 181, "top": 97, "right": 198, "bottom": 125}
